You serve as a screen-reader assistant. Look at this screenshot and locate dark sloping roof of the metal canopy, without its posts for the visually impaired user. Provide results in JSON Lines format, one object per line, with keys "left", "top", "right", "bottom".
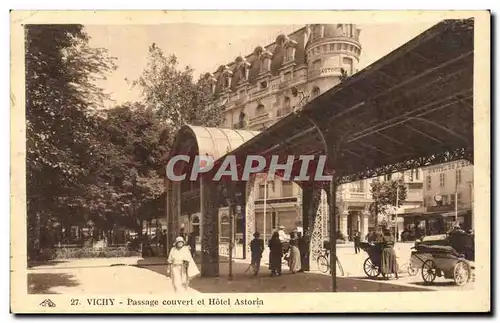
{"left": 207, "top": 19, "right": 474, "bottom": 183}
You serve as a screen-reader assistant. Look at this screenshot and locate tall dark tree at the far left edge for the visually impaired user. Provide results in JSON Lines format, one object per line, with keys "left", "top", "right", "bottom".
{"left": 25, "top": 25, "right": 115, "bottom": 251}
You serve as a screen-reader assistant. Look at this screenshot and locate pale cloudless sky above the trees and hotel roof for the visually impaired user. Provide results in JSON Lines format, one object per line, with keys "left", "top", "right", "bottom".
{"left": 85, "top": 19, "right": 439, "bottom": 107}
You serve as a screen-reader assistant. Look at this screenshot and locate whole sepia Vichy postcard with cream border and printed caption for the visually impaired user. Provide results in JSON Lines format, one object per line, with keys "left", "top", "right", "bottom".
{"left": 11, "top": 11, "right": 491, "bottom": 313}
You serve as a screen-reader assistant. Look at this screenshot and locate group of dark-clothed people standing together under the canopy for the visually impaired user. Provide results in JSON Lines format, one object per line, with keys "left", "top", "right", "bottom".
{"left": 250, "top": 226, "right": 308, "bottom": 277}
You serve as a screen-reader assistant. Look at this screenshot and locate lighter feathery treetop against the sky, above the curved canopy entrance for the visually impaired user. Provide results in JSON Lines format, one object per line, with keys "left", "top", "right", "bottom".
{"left": 133, "top": 43, "right": 225, "bottom": 138}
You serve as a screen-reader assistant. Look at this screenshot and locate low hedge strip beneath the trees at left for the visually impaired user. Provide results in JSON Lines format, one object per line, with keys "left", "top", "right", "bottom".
{"left": 50, "top": 247, "right": 139, "bottom": 259}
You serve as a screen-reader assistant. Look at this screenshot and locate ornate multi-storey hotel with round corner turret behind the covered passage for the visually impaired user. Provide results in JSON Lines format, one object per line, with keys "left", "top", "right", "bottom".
{"left": 176, "top": 24, "right": 422, "bottom": 249}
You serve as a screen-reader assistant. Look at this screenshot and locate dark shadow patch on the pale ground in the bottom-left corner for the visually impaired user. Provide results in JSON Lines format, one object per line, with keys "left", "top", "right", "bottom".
{"left": 28, "top": 273, "right": 79, "bottom": 294}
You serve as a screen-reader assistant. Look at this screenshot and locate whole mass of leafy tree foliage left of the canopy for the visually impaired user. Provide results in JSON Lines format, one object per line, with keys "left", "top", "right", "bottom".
{"left": 26, "top": 32, "right": 224, "bottom": 258}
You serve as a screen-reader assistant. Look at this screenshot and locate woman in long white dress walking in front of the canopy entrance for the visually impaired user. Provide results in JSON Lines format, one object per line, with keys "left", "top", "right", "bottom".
{"left": 167, "top": 237, "right": 200, "bottom": 292}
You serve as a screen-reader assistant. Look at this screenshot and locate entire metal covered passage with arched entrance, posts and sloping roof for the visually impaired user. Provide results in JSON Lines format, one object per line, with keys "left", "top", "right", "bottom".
{"left": 165, "top": 19, "right": 474, "bottom": 291}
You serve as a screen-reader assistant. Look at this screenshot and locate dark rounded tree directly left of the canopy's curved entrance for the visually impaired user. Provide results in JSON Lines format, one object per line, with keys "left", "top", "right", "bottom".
{"left": 96, "top": 103, "right": 169, "bottom": 238}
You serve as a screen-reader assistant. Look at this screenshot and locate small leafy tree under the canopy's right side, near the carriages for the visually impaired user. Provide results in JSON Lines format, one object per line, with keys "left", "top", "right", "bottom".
{"left": 370, "top": 180, "right": 406, "bottom": 228}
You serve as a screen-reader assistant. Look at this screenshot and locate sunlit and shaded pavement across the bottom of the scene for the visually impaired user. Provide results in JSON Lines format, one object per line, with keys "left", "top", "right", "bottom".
{"left": 28, "top": 243, "right": 474, "bottom": 294}
